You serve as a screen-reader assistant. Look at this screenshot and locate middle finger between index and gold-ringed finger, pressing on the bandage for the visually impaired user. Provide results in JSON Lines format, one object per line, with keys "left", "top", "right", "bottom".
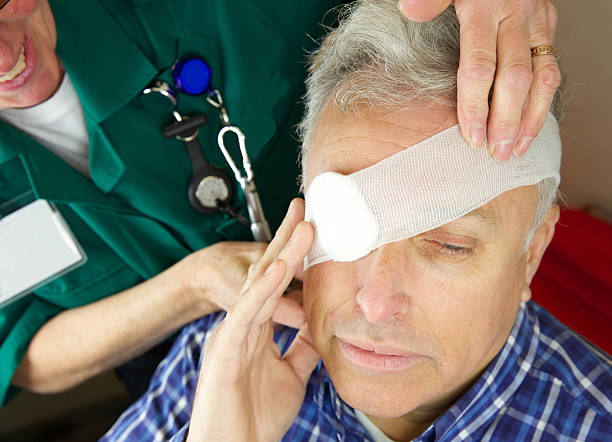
{"left": 488, "top": 10, "right": 532, "bottom": 161}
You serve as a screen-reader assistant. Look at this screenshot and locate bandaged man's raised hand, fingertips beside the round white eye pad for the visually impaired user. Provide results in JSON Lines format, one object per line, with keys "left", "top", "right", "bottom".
{"left": 187, "top": 200, "right": 319, "bottom": 442}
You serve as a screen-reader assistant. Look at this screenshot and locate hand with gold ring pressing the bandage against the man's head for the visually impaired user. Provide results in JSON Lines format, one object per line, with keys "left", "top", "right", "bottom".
{"left": 399, "top": 0, "right": 561, "bottom": 160}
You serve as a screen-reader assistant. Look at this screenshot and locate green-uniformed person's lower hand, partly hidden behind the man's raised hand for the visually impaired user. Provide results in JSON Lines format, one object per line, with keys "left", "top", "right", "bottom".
{"left": 177, "top": 241, "right": 304, "bottom": 327}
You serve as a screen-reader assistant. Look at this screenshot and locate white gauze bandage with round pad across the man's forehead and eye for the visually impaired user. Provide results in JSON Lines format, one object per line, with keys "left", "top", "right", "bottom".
{"left": 304, "top": 114, "right": 561, "bottom": 269}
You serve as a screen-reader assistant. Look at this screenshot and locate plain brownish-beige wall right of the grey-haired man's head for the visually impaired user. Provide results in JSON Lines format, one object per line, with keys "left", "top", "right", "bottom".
{"left": 554, "top": 0, "right": 612, "bottom": 213}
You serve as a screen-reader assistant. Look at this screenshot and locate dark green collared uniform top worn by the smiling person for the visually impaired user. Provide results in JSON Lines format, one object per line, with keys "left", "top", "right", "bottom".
{"left": 0, "top": 0, "right": 336, "bottom": 403}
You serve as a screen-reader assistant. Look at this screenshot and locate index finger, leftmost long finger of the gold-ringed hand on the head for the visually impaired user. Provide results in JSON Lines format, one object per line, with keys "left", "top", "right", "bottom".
{"left": 455, "top": 0, "right": 499, "bottom": 147}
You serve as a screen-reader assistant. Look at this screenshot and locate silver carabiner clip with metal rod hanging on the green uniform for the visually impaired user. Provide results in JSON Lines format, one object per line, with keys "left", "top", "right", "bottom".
{"left": 217, "top": 126, "right": 272, "bottom": 242}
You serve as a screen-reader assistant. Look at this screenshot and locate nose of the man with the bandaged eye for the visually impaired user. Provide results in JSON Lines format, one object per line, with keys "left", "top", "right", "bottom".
{"left": 355, "top": 244, "right": 409, "bottom": 323}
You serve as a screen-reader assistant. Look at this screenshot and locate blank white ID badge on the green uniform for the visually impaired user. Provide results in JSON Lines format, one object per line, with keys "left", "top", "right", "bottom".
{"left": 0, "top": 200, "right": 87, "bottom": 308}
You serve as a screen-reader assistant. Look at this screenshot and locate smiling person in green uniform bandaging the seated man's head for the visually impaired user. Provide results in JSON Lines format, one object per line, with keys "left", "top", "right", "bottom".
{"left": 0, "top": 0, "right": 556, "bottom": 403}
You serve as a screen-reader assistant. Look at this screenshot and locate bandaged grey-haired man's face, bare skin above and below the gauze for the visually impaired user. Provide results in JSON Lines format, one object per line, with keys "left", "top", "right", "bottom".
{"left": 304, "top": 102, "right": 537, "bottom": 417}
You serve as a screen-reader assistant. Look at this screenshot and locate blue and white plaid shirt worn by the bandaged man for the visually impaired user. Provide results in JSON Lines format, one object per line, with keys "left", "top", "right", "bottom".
{"left": 101, "top": 302, "right": 612, "bottom": 442}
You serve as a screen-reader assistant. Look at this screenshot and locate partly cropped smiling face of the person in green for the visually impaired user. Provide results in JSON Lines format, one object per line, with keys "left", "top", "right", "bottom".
{"left": 0, "top": 0, "right": 63, "bottom": 109}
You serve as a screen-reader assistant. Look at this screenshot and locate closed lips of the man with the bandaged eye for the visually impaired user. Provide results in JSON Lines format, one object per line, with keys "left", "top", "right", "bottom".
{"left": 337, "top": 338, "right": 424, "bottom": 372}
